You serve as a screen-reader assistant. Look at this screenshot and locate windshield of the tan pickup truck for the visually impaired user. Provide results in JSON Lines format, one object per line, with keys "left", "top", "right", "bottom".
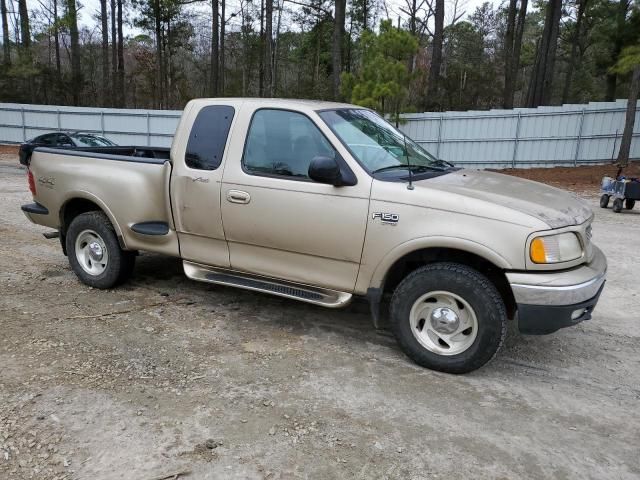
{"left": 319, "top": 108, "right": 447, "bottom": 173}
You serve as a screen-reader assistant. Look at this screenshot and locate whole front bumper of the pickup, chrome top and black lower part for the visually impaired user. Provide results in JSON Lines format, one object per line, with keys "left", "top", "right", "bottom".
{"left": 507, "top": 246, "right": 607, "bottom": 335}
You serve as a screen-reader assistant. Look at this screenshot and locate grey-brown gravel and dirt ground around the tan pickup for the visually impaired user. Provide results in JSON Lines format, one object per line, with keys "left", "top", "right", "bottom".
{"left": 0, "top": 154, "right": 640, "bottom": 480}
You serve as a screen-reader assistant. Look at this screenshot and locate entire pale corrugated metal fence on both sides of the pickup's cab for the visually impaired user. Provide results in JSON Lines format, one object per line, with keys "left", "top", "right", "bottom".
{"left": 0, "top": 100, "right": 640, "bottom": 168}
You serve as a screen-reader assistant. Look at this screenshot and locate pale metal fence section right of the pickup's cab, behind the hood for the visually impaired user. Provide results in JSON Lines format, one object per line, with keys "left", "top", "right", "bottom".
{"left": 400, "top": 100, "right": 640, "bottom": 168}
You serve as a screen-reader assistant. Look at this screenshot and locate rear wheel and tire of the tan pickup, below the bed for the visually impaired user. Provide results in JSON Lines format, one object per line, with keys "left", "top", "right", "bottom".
{"left": 66, "top": 212, "right": 136, "bottom": 289}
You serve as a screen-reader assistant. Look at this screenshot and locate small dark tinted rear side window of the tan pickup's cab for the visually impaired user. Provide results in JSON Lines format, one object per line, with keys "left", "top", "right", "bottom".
{"left": 185, "top": 105, "right": 235, "bottom": 170}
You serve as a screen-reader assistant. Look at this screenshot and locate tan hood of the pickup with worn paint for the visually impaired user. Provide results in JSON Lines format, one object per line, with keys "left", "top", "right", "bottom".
{"left": 416, "top": 170, "right": 593, "bottom": 228}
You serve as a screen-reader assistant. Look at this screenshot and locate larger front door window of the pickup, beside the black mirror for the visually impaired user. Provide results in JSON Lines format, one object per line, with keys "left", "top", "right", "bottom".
{"left": 242, "top": 109, "right": 335, "bottom": 178}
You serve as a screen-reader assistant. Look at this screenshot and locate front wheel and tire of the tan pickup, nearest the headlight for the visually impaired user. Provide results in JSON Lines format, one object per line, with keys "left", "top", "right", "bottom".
{"left": 391, "top": 263, "right": 507, "bottom": 373}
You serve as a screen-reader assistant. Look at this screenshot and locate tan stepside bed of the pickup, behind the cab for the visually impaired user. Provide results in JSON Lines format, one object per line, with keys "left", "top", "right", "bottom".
{"left": 29, "top": 147, "right": 179, "bottom": 256}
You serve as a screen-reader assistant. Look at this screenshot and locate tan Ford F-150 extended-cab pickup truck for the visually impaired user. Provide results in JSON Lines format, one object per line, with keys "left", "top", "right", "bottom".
{"left": 22, "top": 98, "right": 607, "bottom": 373}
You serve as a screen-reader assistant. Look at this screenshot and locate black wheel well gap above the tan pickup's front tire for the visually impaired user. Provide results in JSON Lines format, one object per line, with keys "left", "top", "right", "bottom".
{"left": 383, "top": 248, "right": 517, "bottom": 318}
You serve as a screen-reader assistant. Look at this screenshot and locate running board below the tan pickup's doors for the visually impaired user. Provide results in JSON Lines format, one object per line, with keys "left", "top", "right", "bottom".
{"left": 182, "top": 261, "right": 353, "bottom": 308}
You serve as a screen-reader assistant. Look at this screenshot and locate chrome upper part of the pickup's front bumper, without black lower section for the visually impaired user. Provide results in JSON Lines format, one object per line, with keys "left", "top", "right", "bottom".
{"left": 507, "top": 246, "right": 607, "bottom": 305}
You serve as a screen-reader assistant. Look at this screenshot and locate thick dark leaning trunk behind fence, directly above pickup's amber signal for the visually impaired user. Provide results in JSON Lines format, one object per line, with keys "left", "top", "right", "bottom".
{"left": 527, "top": 0, "right": 562, "bottom": 108}
